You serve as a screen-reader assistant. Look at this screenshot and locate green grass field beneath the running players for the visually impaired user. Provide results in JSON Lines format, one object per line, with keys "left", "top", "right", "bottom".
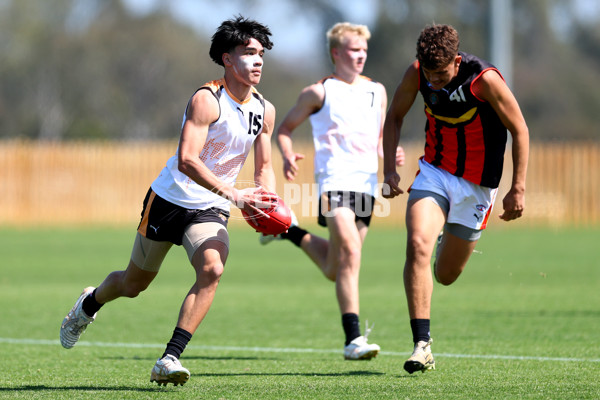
{"left": 0, "top": 223, "right": 600, "bottom": 399}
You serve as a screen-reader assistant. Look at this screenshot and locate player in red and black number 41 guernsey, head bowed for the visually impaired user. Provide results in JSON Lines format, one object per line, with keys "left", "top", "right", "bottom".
{"left": 383, "top": 25, "right": 529, "bottom": 373}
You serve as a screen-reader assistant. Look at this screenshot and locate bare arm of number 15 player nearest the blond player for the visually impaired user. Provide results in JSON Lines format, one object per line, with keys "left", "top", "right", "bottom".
{"left": 254, "top": 100, "right": 275, "bottom": 192}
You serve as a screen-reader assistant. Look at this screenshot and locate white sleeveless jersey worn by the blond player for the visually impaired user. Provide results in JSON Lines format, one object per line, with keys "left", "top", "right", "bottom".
{"left": 310, "top": 76, "right": 383, "bottom": 196}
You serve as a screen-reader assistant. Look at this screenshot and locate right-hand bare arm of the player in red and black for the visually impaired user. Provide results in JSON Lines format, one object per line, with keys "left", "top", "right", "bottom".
{"left": 473, "top": 71, "right": 529, "bottom": 221}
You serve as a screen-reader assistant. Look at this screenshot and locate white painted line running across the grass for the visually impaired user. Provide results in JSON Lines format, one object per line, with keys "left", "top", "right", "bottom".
{"left": 0, "top": 338, "right": 600, "bottom": 363}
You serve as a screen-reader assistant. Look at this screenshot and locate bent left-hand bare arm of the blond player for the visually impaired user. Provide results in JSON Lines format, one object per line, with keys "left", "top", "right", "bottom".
{"left": 277, "top": 83, "right": 325, "bottom": 182}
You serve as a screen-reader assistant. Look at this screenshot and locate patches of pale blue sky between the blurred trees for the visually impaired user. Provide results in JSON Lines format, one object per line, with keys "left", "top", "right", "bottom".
{"left": 118, "top": 0, "right": 600, "bottom": 68}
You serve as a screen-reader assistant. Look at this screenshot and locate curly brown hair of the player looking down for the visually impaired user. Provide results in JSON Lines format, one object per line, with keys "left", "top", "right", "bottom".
{"left": 417, "top": 24, "right": 460, "bottom": 70}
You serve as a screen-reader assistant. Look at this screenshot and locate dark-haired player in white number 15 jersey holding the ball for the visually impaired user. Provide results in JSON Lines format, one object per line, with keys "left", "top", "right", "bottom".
{"left": 60, "top": 16, "right": 275, "bottom": 385}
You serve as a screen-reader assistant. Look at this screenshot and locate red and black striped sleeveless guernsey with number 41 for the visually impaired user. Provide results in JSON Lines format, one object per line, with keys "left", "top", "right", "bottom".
{"left": 419, "top": 52, "right": 507, "bottom": 188}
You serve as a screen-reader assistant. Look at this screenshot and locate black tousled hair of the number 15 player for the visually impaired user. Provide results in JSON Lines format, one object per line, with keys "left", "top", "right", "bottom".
{"left": 209, "top": 15, "right": 273, "bottom": 66}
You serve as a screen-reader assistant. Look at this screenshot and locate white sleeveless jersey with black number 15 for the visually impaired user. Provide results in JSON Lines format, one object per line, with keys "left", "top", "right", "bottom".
{"left": 151, "top": 79, "right": 265, "bottom": 211}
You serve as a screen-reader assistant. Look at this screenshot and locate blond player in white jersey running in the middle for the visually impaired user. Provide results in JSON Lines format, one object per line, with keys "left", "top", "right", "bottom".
{"left": 261, "top": 22, "right": 404, "bottom": 360}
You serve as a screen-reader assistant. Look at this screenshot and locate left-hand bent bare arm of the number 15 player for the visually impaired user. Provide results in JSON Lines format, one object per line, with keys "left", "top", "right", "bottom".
{"left": 178, "top": 90, "right": 244, "bottom": 200}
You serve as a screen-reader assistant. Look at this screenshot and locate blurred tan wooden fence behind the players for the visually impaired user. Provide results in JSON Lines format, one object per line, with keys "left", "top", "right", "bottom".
{"left": 0, "top": 141, "right": 600, "bottom": 227}
